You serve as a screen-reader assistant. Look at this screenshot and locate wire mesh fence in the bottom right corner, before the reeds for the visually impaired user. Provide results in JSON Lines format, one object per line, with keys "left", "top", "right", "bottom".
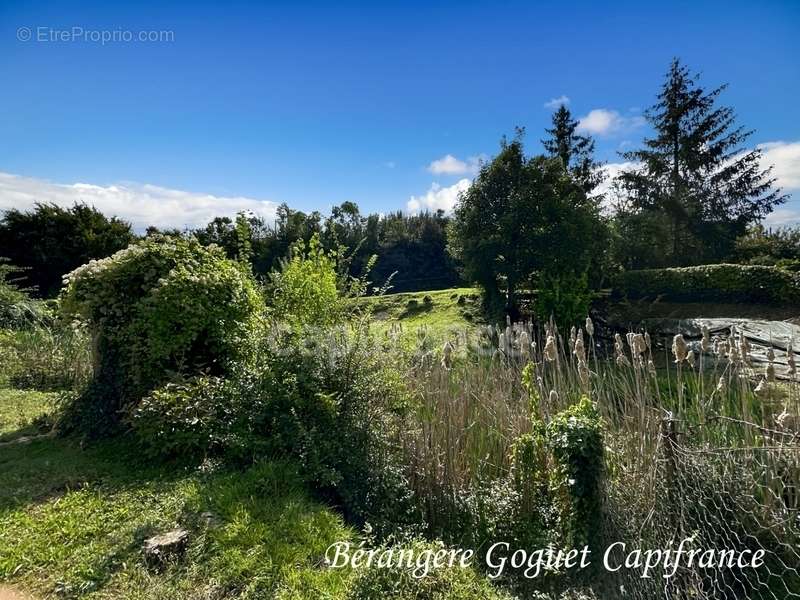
{"left": 601, "top": 419, "right": 800, "bottom": 600}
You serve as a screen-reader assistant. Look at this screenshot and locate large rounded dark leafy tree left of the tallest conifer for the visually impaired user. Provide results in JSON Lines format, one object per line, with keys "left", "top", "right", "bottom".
{"left": 450, "top": 130, "right": 603, "bottom": 317}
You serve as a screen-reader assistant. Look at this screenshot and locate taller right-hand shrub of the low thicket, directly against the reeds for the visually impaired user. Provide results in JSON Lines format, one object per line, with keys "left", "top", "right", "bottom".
{"left": 246, "top": 330, "right": 418, "bottom": 534}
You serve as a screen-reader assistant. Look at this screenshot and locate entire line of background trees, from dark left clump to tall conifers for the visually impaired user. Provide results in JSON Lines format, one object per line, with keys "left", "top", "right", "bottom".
{"left": 0, "top": 59, "right": 800, "bottom": 313}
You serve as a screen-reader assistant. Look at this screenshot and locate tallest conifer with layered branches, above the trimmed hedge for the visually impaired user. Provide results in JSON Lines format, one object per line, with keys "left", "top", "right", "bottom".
{"left": 619, "top": 59, "right": 786, "bottom": 266}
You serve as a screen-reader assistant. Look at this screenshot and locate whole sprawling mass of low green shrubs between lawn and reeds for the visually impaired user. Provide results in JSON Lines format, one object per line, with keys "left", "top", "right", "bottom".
{"left": 132, "top": 322, "right": 415, "bottom": 534}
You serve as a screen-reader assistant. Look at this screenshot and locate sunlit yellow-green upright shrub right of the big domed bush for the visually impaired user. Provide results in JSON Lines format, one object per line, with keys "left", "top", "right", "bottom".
{"left": 269, "top": 234, "right": 346, "bottom": 327}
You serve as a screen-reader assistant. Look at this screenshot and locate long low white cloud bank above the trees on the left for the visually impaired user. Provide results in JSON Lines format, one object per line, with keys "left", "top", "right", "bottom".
{"left": 0, "top": 172, "right": 278, "bottom": 231}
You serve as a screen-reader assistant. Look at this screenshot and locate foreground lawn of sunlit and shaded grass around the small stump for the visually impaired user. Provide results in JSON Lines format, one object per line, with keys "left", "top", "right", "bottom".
{"left": 0, "top": 389, "right": 354, "bottom": 599}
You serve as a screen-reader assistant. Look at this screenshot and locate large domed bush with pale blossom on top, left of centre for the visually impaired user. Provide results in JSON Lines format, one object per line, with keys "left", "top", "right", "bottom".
{"left": 57, "top": 236, "right": 261, "bottom": 435}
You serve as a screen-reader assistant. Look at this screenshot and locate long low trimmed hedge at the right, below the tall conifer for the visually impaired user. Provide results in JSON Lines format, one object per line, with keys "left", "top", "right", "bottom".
{"left": 614, "top": 264, "right": 800, "bottom": 305}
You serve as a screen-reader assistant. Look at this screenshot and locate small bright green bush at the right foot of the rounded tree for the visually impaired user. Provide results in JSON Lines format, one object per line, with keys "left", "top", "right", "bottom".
{"left": 535, "top": 271, "right": 592, "bottom": 329}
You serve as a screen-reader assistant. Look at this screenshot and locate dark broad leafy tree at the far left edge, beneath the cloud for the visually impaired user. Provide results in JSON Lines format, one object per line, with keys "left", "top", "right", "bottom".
{"left": 0, "top": 204, "right": 135, "bottom": 298}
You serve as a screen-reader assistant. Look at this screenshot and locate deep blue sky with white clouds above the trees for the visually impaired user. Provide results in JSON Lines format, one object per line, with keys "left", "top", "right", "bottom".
{"left": 0, "top": 0, "right": 800, "bottom": 230}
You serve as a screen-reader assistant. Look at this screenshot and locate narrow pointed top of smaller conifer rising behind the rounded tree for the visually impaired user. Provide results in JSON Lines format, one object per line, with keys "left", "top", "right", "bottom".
{"left": 542, "top": 104, "right": 605, "bottom": 200}
